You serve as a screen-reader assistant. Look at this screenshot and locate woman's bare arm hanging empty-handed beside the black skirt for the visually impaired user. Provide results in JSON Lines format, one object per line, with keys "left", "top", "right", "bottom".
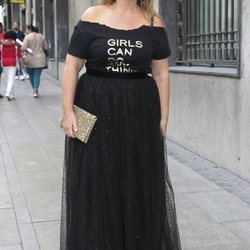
{"left": 152, "top": 58, "right": 170, "bottom": 136}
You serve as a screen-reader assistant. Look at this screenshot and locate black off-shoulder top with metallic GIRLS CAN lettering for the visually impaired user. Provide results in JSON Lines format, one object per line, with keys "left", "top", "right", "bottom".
{"left": 68, "top": 20, "right": 171, "bottom": 74}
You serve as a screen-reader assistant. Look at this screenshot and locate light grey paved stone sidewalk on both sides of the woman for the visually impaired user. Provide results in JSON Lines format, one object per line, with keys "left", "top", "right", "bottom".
{"left": 0, "top": 73, "right": 250, "bottom": 250}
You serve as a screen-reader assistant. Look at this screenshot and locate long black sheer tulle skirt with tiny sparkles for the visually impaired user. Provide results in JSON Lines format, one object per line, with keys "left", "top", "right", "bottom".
{"left": 60, "top": 73, "right": 181, "bottom": 250}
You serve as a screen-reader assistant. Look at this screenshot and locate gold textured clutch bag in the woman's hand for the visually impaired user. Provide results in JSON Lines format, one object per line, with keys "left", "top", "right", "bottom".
{"left": 61, "top": 105, "right": 97, "bottom": 143}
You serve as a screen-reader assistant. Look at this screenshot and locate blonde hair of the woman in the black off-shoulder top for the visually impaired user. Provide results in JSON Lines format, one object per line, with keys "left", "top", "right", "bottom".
{"left": 100, "top": 0, "right": 160, "bottom": 20}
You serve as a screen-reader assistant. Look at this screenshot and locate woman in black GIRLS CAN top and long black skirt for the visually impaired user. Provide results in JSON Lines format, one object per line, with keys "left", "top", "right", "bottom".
{"left": 60, "top": 0, "right": 181, "bottom": 250}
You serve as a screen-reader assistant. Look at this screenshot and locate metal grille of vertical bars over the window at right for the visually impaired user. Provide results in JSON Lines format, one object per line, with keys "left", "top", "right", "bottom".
{"left": 177, "top": 0, "right": 239, "bottom": 67}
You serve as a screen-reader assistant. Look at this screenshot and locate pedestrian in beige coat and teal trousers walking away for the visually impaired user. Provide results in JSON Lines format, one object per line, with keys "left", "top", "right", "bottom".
{"left": 22, "top": 25, "right": 48, "bottom": 98}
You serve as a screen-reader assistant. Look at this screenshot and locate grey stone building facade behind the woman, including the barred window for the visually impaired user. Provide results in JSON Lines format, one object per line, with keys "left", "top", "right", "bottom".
{"left": 5, "top": 0, "right": 250, "bottom": 183}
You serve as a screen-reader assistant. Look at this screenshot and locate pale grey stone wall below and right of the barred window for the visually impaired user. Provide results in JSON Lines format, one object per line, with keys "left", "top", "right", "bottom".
{"left": 163, "top": 0, "right": 250, "bottom": 180}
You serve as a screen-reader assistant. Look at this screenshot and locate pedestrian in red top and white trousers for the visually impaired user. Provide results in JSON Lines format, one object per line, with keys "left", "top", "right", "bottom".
{"left": 1, "top": 30, "right": 22, "bottom": 101}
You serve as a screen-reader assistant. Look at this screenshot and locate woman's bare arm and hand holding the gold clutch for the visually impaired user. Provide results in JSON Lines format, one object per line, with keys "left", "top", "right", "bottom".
{"left": 62, "top": 54, "right": 85, "bottom": 138}
